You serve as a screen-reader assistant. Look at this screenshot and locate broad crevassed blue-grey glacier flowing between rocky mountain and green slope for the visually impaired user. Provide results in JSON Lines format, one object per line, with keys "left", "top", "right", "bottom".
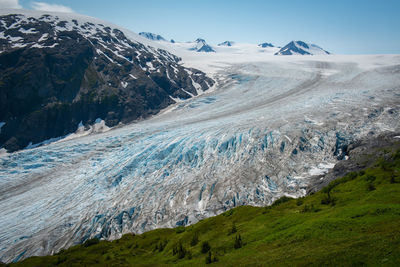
{"left": 0, "top": 61, "right": 400, "bottom": 261}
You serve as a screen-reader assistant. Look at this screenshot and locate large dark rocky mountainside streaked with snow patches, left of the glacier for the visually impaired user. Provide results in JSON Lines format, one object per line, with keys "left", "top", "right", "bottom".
{"left": 0, "top": 15, "right": 214, "bottom": 151}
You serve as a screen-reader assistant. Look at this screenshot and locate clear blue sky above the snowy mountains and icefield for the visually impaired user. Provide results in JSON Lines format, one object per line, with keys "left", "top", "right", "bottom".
{"left": 5, "top": 0, "right": 400, "bottom": 54}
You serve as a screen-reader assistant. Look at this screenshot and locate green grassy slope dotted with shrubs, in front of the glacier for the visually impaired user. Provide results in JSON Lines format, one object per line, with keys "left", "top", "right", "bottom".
{"left": 8, "top": 151, "right": 400, "bottom": 266}
